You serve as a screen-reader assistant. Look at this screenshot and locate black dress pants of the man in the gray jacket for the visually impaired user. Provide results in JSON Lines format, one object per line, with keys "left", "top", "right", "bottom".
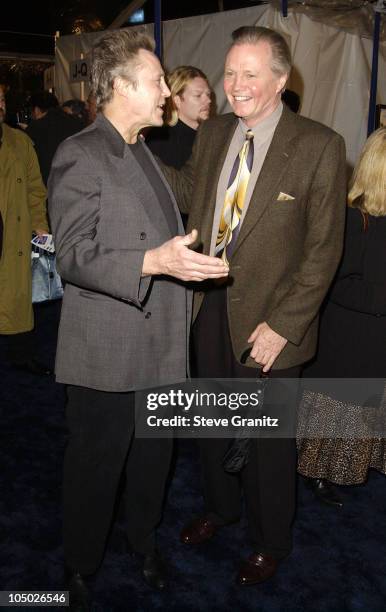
{"left": 63, "top": 386, "right": 172, "bottom": 574}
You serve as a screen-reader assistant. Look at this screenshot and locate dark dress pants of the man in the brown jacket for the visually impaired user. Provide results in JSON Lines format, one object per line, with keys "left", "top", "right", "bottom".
{"left": 193, "top": 287, "right": 300, "bottom": 559}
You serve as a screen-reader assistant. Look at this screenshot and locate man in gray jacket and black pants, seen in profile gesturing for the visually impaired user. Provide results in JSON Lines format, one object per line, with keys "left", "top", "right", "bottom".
{"left": 49, "top": 31, "right": 228, "bottom": 610}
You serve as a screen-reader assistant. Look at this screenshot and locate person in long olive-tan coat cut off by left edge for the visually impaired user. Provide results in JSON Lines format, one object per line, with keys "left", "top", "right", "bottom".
{"left": 0, "top": 84, "right": 48, "bottom": 373}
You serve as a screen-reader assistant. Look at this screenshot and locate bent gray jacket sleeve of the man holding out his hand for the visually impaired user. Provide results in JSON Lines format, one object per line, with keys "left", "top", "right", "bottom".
{"left": 49, "top": 140, "right": 151, "bottom": 308}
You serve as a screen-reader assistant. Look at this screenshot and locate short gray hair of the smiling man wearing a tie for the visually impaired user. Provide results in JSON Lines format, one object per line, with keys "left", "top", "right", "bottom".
{"left": 230, "top": 26, "right": 292, "bottom": 76}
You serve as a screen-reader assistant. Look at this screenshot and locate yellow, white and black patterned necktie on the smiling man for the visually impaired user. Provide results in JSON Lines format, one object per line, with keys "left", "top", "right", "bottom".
{"left": 214, "top": 130, "right": 253, "bottom": 263}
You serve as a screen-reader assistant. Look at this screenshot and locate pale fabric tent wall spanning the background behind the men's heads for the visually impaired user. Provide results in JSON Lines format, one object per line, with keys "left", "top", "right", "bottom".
{"left": 55, "top": 5, "right": 386, "bottom": 164}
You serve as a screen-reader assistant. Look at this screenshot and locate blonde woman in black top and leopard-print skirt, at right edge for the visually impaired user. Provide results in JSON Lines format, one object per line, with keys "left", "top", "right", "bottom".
{"left": 298, "top": 127, "right": 386, "bottom": 507}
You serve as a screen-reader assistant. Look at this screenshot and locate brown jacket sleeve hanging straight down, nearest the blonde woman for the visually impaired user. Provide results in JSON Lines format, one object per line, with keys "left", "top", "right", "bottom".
{"left": 267, "top": 133, "right": 346, "bottom": 345}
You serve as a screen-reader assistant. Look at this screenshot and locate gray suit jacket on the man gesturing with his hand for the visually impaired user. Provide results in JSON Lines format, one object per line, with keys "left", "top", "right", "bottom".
{"left": 49, "top": 115, "right": 191, "bottom": 392}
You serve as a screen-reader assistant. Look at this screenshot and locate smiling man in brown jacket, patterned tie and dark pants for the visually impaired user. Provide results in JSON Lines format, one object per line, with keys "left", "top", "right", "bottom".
{"left": 166, "top": 27, "right": 346, "bottom": 584}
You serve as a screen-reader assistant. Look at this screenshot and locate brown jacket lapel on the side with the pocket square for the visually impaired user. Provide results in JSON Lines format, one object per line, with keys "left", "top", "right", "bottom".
{"left": 233, "top": 107, "right": 297, "bottom": 255}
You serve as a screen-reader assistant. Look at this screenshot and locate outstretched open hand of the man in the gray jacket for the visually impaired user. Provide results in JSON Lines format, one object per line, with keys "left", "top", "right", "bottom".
{"left": 142, "top": 229, "right": 229, "bottom": 281}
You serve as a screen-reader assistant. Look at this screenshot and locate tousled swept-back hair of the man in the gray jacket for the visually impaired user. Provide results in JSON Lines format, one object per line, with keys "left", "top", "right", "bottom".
{"left": 91, "top": 29, "right": 155, "bottom": 110}
